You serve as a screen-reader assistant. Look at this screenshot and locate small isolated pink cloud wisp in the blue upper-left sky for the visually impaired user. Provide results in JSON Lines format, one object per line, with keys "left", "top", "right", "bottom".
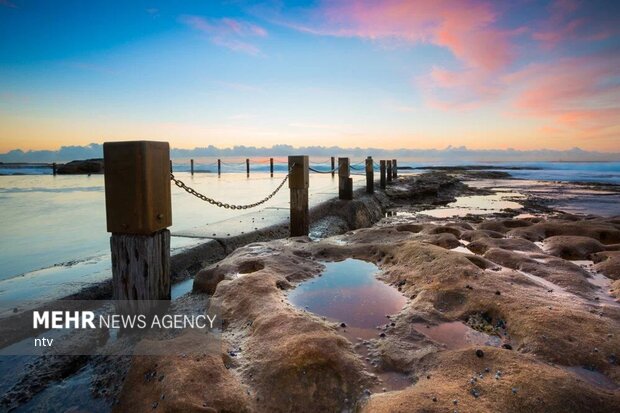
{"left": 180, "top": 16, "right": 267, "bottom": 56}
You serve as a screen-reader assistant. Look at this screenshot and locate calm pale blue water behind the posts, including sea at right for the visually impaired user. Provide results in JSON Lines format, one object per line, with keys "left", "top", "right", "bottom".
{"left": 0, "top": 159, "right": 620, "bottom": 308}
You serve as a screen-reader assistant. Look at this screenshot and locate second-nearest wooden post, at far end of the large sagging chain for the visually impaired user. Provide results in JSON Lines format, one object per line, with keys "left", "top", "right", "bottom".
{"left": 288, "top": 156, "right": 310, "bottom": 237}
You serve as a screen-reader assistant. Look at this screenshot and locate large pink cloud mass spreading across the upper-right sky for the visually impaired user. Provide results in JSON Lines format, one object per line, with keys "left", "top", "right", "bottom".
{"left": 264, "top": 0, "right": 620, "bottom": 142}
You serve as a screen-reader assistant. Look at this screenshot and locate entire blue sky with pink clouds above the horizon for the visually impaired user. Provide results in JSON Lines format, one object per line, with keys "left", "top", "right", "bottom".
{"left": 0, "top": 0, "right": 620, "bottom": 153}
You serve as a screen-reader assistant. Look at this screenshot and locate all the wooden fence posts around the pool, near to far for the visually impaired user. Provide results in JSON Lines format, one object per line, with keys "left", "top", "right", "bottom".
{"left": 103, "top": 141, "right": 397, "bottom": 304}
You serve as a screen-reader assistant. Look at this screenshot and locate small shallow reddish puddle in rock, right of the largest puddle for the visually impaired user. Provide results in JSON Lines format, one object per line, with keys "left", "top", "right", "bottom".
{"left": 413, "top": 321, "right": 503, "bottom": 350}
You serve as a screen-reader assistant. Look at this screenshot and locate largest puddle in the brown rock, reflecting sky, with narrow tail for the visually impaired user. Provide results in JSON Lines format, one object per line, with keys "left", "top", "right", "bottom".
{"left": 288, "top": 259, "right": 411, "bottom": 391}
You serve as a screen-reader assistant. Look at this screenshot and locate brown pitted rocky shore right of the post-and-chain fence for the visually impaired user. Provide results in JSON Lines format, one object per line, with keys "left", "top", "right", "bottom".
{"left": 3, "top": 171, "right": 620, "bottom": 412}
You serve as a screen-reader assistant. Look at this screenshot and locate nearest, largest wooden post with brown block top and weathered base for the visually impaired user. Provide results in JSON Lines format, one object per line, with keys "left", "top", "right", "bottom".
{"left": 103, "top": 141, "right": 172, "bottom": 313}
